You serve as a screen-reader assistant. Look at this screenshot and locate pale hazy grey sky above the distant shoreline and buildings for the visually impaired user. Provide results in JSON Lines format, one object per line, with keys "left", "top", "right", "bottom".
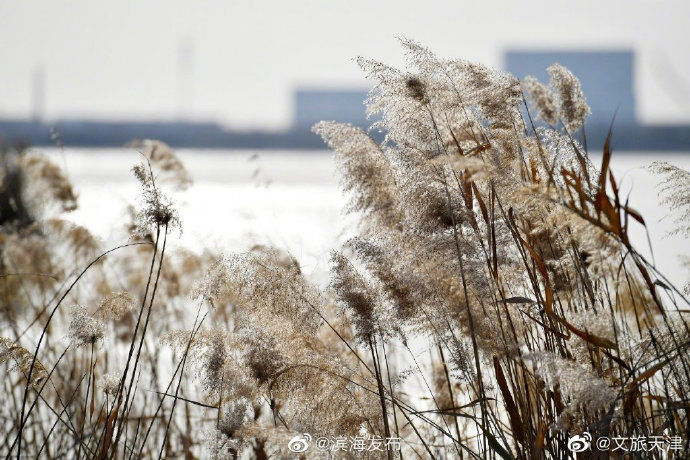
{"left": 0, "top": 0, "right": 690, "bottom": 127}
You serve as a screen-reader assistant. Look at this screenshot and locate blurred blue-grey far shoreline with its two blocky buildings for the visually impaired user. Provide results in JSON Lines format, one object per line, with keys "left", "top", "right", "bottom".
{"left": 0, "top": 50, "right": 690, "bottom": 151}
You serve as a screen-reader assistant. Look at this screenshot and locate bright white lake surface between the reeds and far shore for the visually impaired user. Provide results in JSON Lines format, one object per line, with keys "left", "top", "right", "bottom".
{"left": 41, "top": 149, "right": 690, "bottom": 285}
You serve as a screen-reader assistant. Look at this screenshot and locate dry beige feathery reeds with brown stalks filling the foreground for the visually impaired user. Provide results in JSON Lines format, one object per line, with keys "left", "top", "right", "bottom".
{"left": 0, "top": 41, "right": 690, "bottom": 459}
